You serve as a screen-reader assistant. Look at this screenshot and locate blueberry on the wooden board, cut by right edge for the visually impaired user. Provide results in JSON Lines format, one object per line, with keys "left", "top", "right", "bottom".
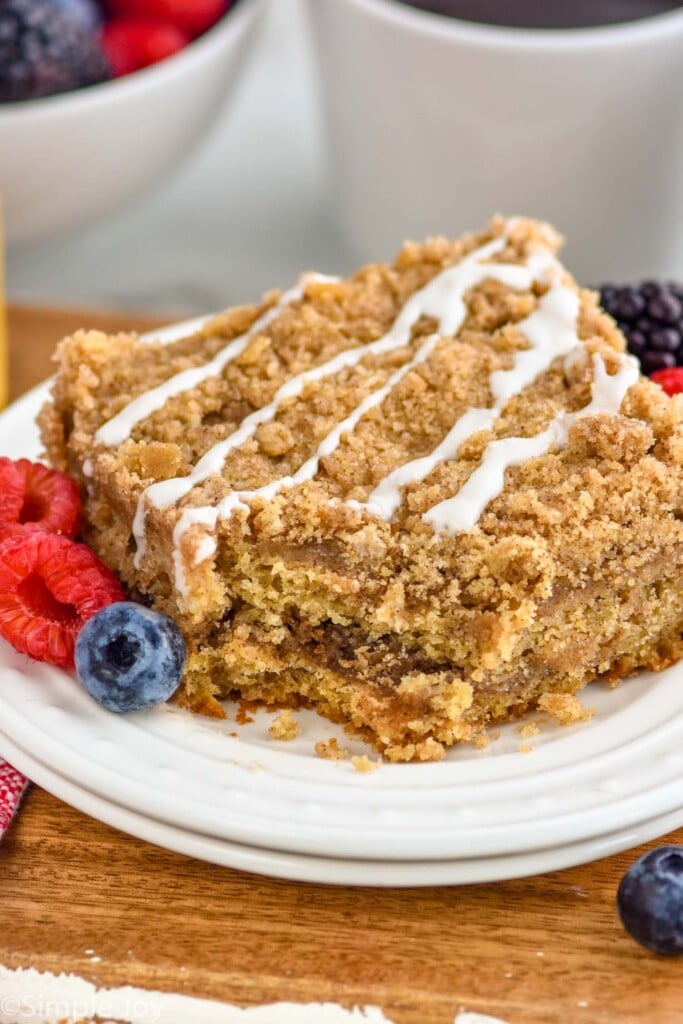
{"left": 616, "top": 846, "right": 683, "bottom": 956}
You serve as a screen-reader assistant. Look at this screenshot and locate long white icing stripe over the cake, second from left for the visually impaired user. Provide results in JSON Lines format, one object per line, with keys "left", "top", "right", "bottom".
{"left": 131, "top": 234, "right": 536, "bottom": 567}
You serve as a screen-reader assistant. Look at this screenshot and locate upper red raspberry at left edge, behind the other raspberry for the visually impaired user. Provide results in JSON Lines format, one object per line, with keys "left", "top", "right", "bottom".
{"left": 0, "top": 457, "right": 81, "bottom": 541}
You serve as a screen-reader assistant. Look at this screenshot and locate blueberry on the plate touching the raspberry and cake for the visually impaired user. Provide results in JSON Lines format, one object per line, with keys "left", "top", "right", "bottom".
{"left": 76, "top": 601, "right": 186, "bottom": 712}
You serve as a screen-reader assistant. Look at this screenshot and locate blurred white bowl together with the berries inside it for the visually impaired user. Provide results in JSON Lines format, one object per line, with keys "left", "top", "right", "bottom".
{"left": 0, "top": 0, "right": 264, "bottom": 244}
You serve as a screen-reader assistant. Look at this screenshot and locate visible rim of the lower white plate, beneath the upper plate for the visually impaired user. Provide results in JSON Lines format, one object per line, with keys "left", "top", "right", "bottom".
{"left": 0, "top": 732, "right": 681, "bottom": 887}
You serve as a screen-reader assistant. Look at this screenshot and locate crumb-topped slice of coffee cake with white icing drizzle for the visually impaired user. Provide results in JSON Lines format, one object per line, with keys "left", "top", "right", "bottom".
{"left": 41, "top": 219, "right": 683, "bottom": 760}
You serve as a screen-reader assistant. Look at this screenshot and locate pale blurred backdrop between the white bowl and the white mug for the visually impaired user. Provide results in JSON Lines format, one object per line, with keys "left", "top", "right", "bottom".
{"left": 6, "top": 0, "right": 353, "bottom": 316}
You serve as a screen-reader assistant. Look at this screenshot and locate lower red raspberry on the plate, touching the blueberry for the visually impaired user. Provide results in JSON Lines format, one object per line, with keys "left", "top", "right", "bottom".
{"left": 0, "top": 530, "right": 124, "bottom": 669}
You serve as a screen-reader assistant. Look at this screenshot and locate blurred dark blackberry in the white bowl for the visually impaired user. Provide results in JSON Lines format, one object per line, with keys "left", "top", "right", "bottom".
{"left": 0, "top": 0, "right": 111, "bottom": 102}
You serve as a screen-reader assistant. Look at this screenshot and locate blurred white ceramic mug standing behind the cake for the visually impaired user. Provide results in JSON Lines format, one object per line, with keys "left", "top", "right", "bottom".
{"left": 308, "top": 0, "right": 683, "bottom": 284}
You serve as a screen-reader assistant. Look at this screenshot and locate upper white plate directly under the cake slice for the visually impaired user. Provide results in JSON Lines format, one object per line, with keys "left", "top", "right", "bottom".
{"left": 0, "top": 372, "right": 683, "bottom": 869}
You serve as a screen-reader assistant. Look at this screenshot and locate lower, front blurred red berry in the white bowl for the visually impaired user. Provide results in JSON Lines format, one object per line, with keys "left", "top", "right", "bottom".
{"left": 101, "top": 16, "right": 189, "bottom": 78}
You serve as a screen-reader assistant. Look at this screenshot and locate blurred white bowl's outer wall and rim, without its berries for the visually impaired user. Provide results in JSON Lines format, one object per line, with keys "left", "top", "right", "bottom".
{"left": 0, "top": 0, "right": 263, "bottom": 244}
